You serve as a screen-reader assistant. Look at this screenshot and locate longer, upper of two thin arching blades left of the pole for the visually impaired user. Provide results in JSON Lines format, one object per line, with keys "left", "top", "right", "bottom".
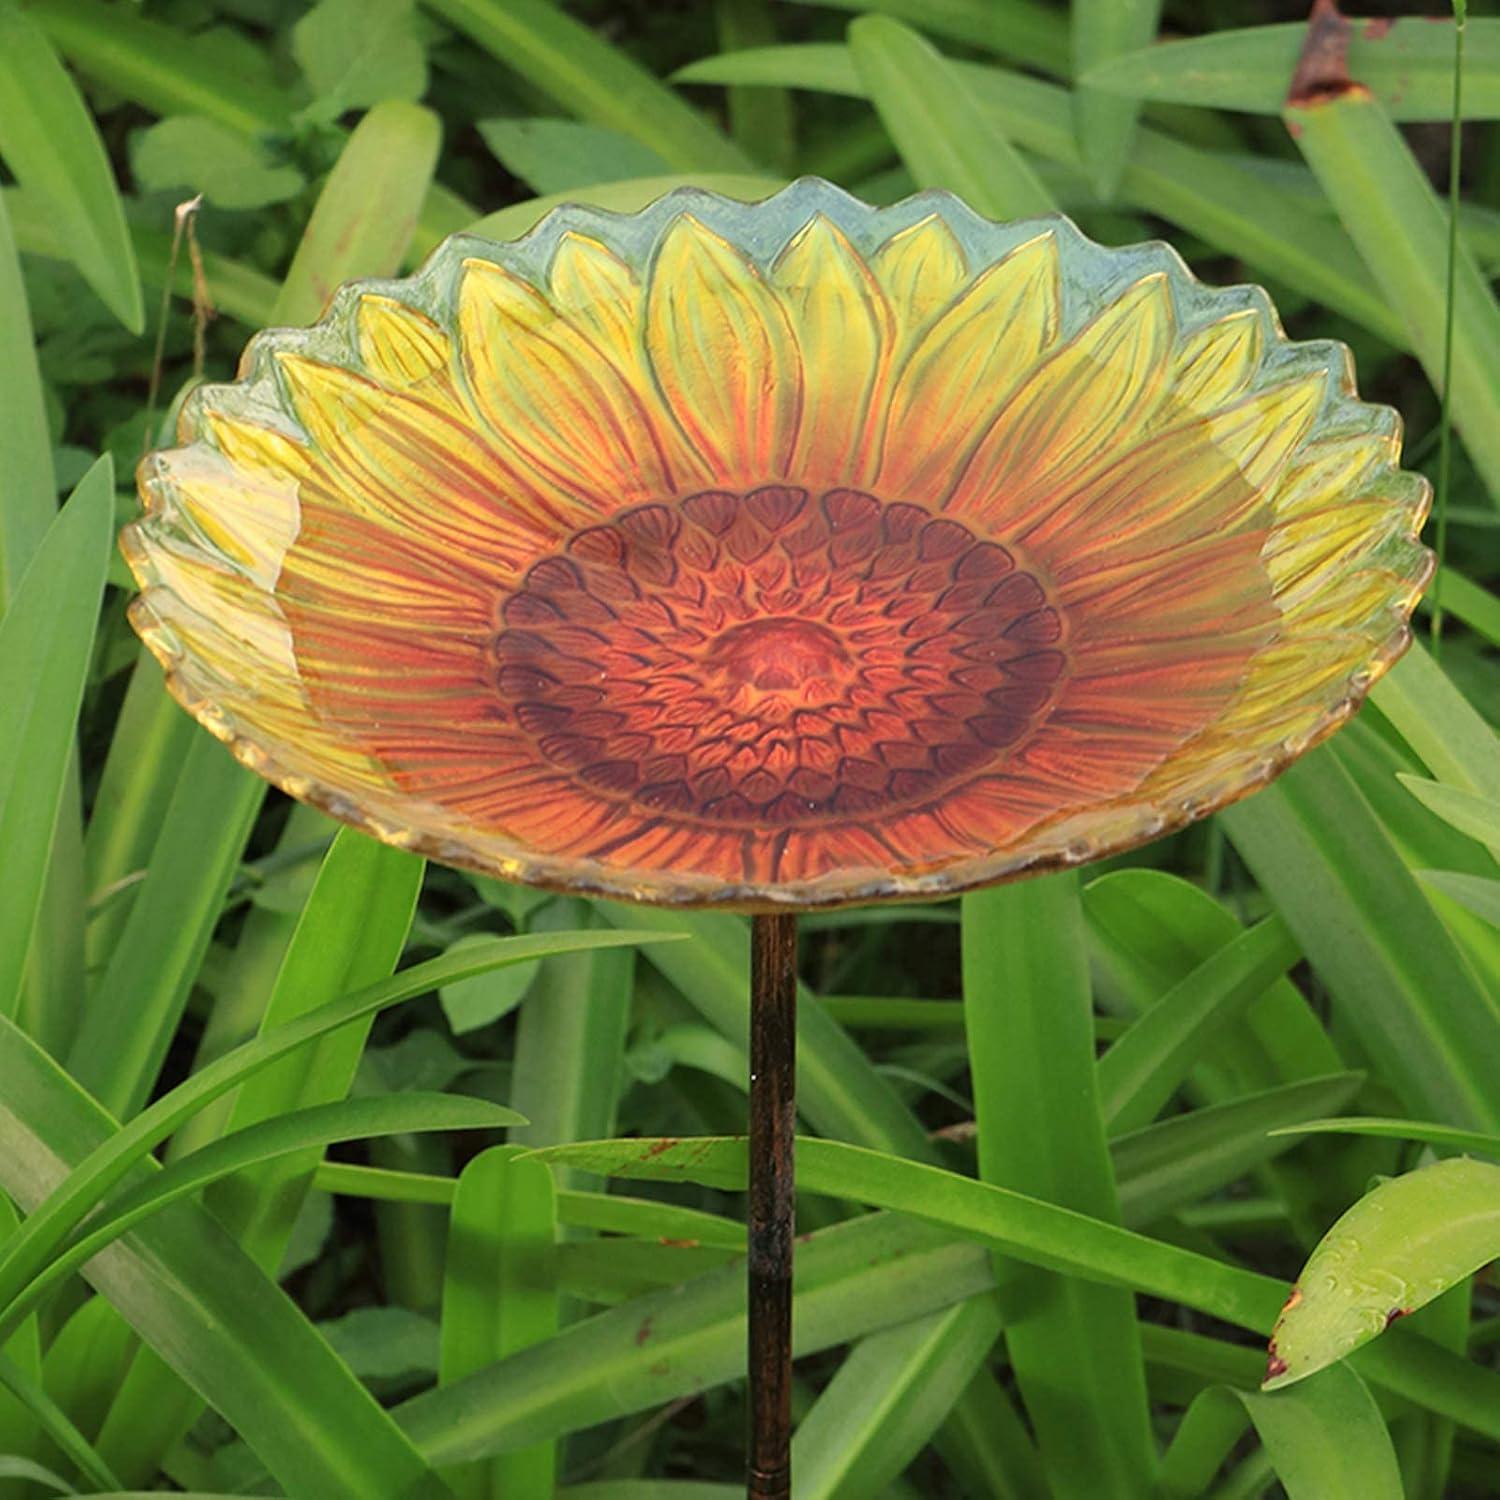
{"left": 0, "top": 933, "right": 675, "bottom": 1304}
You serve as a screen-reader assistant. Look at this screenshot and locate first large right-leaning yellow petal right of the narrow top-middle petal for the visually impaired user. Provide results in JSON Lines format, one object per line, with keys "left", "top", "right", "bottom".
{"left": 881, "top": 233, "right": 1059, "bottom": 500}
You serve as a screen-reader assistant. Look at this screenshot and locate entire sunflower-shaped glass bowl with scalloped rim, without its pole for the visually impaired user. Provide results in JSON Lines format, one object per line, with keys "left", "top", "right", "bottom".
{"left": 123, "top": 182, "right": 1431, "bottom": 909}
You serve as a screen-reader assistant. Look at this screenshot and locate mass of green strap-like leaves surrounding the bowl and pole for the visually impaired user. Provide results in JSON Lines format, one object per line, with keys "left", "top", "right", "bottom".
{"left": 0, "top": 0, "right": 1500, "bottom": 1500}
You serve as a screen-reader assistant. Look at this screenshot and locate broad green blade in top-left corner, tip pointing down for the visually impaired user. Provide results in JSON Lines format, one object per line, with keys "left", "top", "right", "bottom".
{"left": 0, "top": 0, "right": 146, "bottom": 333}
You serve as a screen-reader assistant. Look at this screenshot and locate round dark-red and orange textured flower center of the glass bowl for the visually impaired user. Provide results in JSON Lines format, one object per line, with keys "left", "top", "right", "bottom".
{"left": 494, "top": 485, "right": 1067, "bottom": 827}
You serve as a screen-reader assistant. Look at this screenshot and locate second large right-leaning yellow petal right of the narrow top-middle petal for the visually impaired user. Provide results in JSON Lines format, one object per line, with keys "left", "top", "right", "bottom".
{"left": 948, "top": 272, "right": 1175, "bottom": 530}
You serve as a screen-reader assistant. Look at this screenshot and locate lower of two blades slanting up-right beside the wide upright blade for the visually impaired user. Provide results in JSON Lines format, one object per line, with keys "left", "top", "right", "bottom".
{"left": 1112, "top": 1073, "right": 1365, "bottom": 1227}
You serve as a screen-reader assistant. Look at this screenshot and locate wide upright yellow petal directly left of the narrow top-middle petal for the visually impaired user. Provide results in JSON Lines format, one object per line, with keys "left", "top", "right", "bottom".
{"left": 645, "top": 213, "right": 803, "bottom": 488}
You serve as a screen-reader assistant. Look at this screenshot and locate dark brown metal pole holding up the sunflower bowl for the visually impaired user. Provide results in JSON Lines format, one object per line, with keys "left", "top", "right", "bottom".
{"left": 746, "top": 912, "right": 797, "bottom": 1500}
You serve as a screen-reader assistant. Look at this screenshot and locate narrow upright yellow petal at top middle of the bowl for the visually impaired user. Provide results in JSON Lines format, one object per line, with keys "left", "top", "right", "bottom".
{"left": 771, "top": 215, "right": 896, "bottom": 486}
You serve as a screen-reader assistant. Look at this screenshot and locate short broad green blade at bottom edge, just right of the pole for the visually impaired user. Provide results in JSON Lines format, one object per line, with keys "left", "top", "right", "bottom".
{"left": 792, "top": 1298, "right": 1001, "bottom": 1500}
